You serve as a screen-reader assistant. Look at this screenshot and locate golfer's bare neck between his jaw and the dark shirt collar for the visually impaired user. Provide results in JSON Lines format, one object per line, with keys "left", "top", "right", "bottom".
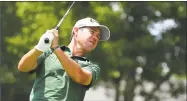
{"left": 68, "top": 39, "right": 85, "bottom": 56}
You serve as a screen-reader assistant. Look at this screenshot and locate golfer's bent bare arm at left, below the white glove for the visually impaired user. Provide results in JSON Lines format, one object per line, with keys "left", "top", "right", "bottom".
{"left": 18, "top": 48, "right": 42, "bottom": 72}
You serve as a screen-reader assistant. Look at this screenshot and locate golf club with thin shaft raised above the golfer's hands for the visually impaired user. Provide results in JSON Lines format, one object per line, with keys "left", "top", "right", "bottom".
{"left": 44, "top": 1, "right": 75, "bottom": 43}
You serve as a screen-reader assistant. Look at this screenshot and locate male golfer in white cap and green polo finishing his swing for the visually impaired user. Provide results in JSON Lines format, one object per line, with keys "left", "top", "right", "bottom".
{"left": 18, "top": 17, "right": 110, "bottom": 101}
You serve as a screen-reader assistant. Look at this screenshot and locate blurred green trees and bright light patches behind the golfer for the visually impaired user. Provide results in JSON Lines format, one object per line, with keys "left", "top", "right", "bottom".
{"left": 0, "top": 1, "right": 187, "bottom": 101}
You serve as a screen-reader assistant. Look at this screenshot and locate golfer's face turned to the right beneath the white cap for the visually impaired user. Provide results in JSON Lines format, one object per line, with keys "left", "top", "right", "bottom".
{"left": 77, "top": 27, "right": 100, "bottom": 52}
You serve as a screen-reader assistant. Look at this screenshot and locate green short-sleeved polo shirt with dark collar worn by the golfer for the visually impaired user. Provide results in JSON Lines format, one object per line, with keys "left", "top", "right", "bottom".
{"left": 30, "top": 46, "right": 100, "bottom": 101}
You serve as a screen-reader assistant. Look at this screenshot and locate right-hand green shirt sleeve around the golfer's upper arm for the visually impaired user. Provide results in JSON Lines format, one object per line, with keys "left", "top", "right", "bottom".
{"left": 83, "top": 63, "right": 100, "bottom": 87}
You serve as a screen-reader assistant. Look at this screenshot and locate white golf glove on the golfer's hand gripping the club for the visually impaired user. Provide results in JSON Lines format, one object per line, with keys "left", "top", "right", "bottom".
{"left": 35, "top": 30, "right": 54, "bottom": 52}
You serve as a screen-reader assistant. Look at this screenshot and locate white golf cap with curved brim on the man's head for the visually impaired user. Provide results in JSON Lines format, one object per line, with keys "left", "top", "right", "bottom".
{"left": 71, "top": 17, "right": 110, "bottom": 41}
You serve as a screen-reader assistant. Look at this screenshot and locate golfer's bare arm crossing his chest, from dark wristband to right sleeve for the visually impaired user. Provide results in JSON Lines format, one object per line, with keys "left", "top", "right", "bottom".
{"left": 54, "top": 48, "right": 92, "bottom": 85}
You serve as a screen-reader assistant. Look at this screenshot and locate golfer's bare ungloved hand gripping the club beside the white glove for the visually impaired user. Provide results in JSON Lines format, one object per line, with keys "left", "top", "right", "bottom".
{"left": 51, "top": 29, "right": 59, "bottom": 48}
